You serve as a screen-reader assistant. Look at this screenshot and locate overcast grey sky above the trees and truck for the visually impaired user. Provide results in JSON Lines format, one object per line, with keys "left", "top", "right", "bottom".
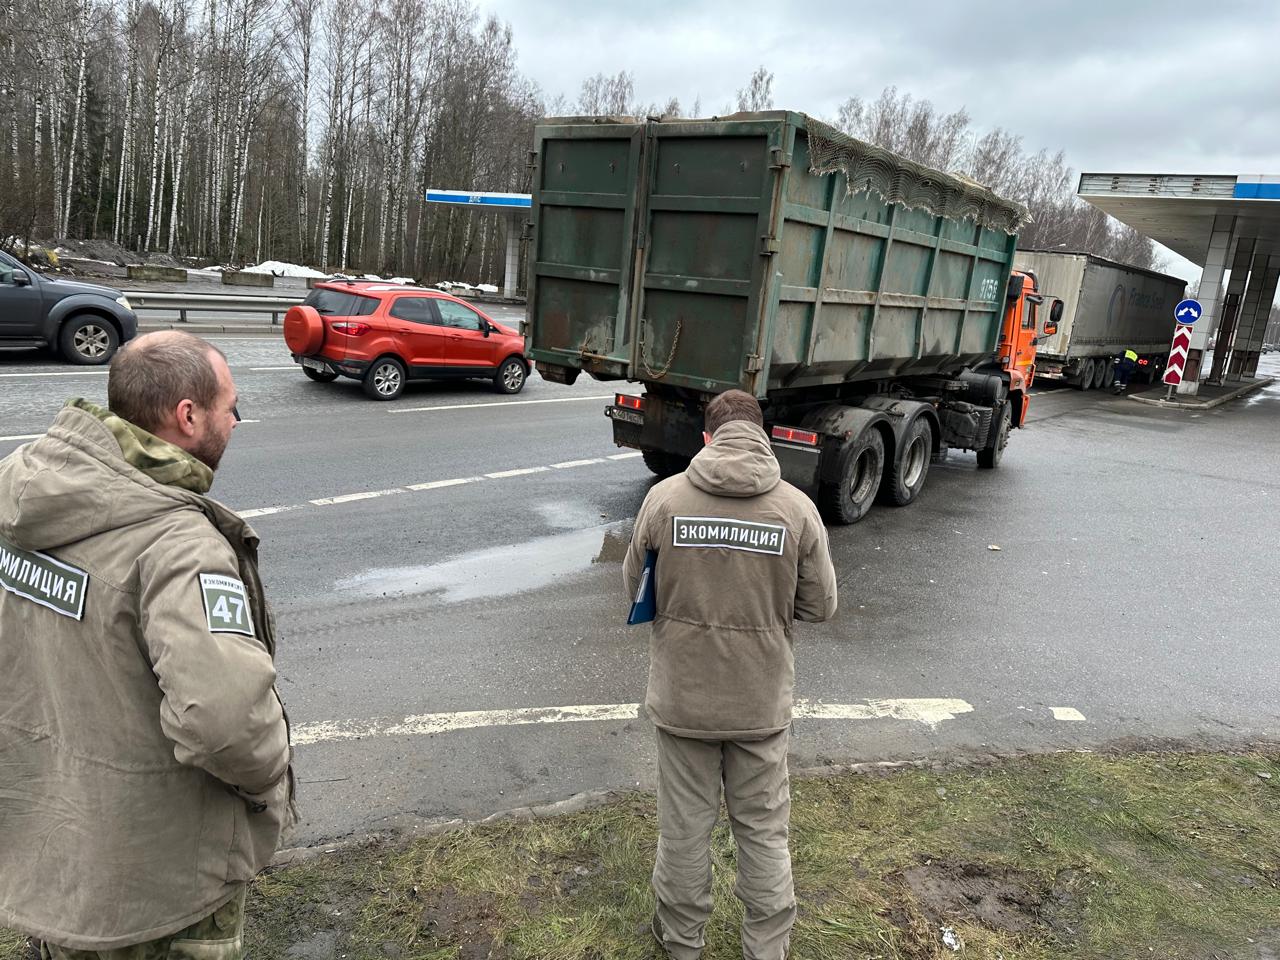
{"left": 479, "top": 0, "right": 1280, "bottom": 285}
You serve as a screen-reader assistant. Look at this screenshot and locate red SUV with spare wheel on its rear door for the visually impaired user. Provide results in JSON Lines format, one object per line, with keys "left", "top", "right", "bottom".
{"left": 284, "top": 280, "right": 529, "bottom": 399}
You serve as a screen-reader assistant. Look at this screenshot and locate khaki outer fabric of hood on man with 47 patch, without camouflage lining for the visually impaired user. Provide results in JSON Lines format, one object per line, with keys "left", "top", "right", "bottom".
{"left": 0, "top": 406, "right": 209, "bottom": 550}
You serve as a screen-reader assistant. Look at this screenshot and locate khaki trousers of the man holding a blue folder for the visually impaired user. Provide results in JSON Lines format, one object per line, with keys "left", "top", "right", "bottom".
{"left": 653, "top": 730, "right": 796, "bottom": 960}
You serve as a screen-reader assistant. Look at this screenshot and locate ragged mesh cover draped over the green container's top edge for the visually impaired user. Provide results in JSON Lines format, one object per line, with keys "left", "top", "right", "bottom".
{"left": 805, "top": 118, "right": 1032, "bottom": 233}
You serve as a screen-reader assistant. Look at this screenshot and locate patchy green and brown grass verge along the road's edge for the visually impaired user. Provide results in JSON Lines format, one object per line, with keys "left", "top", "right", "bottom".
{"left": 0, "top": 753, "right": 1280, "bottom": 960}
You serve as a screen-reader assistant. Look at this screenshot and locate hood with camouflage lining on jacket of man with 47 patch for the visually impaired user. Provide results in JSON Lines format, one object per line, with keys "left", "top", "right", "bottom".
{"left": 0, "top": 399, "right": 214, "bottom": 550}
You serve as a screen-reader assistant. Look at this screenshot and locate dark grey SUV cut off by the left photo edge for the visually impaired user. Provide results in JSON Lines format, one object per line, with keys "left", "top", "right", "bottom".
{"left": 0, "top": 252, "right": 138, "bottom": 364}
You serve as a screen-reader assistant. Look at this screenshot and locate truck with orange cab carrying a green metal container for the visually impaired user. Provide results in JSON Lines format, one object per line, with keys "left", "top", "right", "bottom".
{"left": 529, "top": 111, "right": 1041, "bottom": 524}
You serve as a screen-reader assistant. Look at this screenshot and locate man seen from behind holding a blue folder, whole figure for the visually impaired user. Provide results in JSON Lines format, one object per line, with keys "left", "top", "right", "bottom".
{"left": 623, "top": 390, "right": 836, "bottom": 960}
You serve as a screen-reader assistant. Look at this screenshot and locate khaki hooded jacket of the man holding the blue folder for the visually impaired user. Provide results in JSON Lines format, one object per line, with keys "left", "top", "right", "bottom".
{"left": 623, "top": 421, "right": 836, "bottom": 740}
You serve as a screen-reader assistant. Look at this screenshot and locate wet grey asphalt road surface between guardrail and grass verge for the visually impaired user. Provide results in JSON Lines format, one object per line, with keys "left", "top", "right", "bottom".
{"left": 0, "top": 332, "right": 1280, "bottom": 844}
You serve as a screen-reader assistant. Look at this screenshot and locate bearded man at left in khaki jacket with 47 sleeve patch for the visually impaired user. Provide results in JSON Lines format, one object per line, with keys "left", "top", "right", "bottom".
{"left": 0, "top": 333, "right": 293, "bottom": 960}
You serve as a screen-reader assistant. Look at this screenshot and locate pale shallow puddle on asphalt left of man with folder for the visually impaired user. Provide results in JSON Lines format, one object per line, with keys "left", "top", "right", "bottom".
{"left": 335, "top": 520, "right": 631, "bottom": 603}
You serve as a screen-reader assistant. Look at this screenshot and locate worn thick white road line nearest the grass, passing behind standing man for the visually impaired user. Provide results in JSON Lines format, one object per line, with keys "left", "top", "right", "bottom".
{"left": 291, "top": 699, "right": 973, "bottom": 746}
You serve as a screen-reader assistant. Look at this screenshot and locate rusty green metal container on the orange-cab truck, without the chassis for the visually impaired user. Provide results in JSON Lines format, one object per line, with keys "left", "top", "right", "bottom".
{"left": 529, "top": 113, "right": 1025, "bottom": 397}
